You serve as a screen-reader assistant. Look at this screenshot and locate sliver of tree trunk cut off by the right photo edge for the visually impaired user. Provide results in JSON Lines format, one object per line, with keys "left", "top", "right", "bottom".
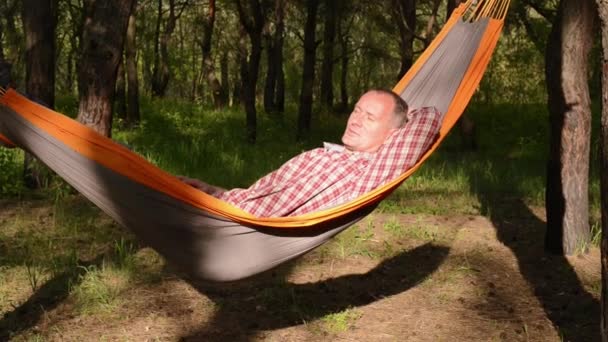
{"left": 596, "top": 0, "right": 608, "bottom": 336}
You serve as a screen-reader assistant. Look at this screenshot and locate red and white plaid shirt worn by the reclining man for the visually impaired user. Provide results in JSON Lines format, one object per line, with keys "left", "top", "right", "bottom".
{"left": 215, "top": 107, "right": 441, "bottom": 217}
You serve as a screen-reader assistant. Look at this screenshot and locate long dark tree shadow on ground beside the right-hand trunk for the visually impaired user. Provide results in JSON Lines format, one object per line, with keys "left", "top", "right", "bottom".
{"left": 471, "top": 173, "right": 600, "bottom": 341}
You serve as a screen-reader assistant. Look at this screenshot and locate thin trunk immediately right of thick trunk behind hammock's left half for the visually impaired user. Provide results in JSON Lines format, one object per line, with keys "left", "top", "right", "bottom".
{"left": 125, "top": 5, "right": 139, "bottom": 126}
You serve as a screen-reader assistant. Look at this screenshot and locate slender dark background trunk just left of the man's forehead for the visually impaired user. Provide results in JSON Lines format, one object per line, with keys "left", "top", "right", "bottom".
{"left": 321, "top": 0, "right": 336, "bottom": 109}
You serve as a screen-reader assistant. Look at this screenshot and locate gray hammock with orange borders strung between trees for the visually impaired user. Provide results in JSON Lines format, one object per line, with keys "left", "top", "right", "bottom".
{"left": 0, "top": 0, "right": 510, "bottom": 281}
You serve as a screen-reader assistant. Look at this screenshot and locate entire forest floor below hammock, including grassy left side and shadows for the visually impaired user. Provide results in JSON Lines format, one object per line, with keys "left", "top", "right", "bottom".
{"left": 0, "top": 195, "right": 601, "bottom": 341}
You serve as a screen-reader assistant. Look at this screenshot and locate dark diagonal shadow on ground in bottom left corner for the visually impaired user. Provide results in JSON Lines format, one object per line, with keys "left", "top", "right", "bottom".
{"left": 0, "top": 253, "right": 105, "bottom": 341}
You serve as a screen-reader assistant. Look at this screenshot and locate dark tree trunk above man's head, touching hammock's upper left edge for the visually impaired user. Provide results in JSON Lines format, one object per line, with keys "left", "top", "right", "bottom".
{"left": 392, "top": 0, "right": 416, "bottom": 79}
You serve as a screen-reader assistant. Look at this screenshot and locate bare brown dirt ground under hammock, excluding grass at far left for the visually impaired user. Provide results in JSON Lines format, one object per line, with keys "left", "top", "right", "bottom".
{"left": 0, "top": 202, "right": 600, "bottom": 341}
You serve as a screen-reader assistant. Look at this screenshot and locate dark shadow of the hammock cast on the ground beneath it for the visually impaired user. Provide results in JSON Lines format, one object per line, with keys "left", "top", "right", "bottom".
{"left": 180, "top": 243, "right": 449, "bottom": 341}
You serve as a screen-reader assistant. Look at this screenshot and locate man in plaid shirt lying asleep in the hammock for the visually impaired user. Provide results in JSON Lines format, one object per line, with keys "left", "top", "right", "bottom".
{"left": 180, "top": 89, "right": 440, "bottom": 217}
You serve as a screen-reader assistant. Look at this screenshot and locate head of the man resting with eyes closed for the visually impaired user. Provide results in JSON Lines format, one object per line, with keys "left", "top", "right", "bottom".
{"left": 342, "top": 89, "right": 407, "bottom": 152}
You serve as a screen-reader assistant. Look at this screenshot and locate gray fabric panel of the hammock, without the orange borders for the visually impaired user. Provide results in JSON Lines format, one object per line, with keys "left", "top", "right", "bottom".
{"left": 0, "top": 19, "right": 488, "bottom": 281}
